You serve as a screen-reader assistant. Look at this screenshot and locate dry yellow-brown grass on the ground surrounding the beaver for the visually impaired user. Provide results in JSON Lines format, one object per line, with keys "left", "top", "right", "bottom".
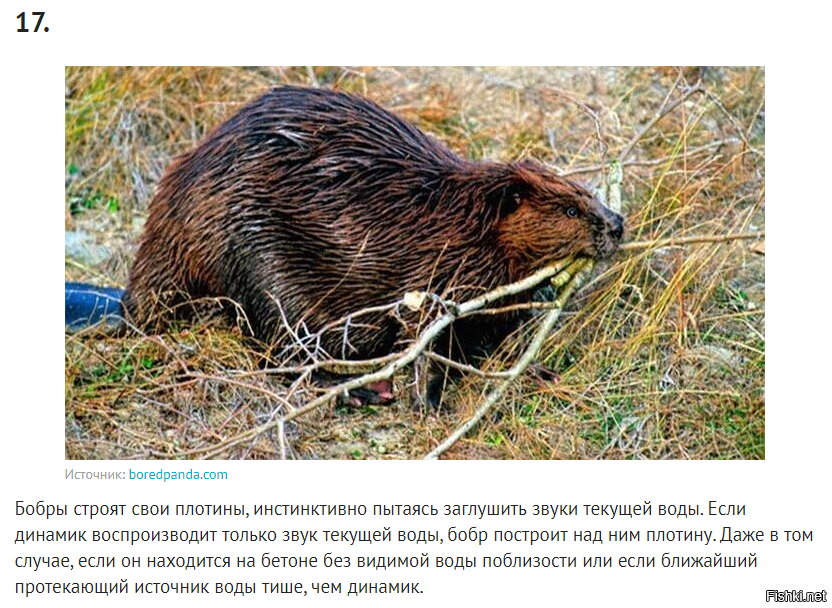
{"left": 65, "top": 68, "right": 765, "bottom": 459}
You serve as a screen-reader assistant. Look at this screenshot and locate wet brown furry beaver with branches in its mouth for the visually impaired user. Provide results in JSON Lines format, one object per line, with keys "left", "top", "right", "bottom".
{"left": 68, "top": 86, "right": 623, "bottom": 405}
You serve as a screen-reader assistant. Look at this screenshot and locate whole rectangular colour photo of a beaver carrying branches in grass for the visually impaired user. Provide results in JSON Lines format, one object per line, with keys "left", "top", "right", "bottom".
{"left": 64, "top": 66, "right": 766, "bottom": 460}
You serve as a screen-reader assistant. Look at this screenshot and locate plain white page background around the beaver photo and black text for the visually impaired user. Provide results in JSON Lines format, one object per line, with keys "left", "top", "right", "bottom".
{"left": 0, "top": 1, "right": 832, "bottom": 606}
